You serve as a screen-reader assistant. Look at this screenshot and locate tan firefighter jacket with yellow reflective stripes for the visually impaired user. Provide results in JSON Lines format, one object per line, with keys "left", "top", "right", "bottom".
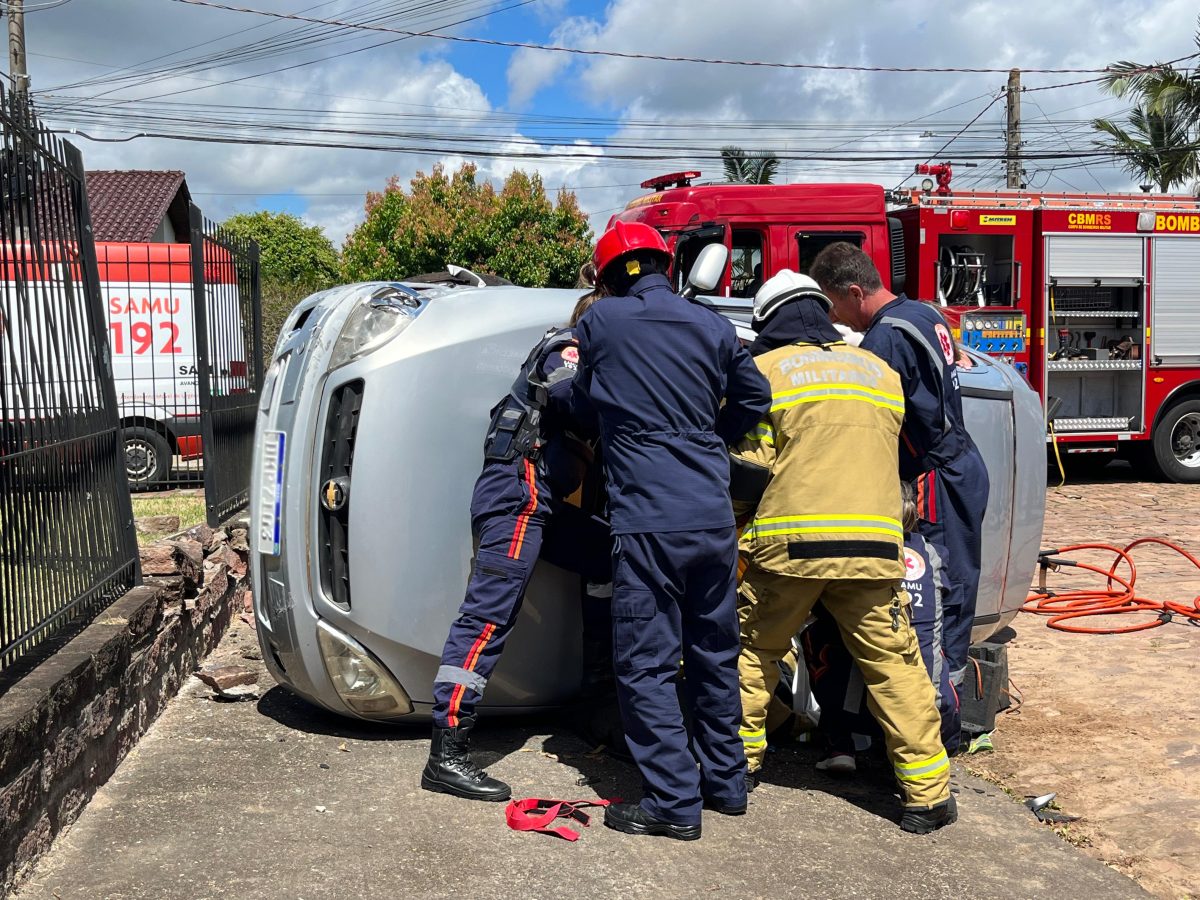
{"left": 734, "top": 343, "right": 905, "bottom": 578}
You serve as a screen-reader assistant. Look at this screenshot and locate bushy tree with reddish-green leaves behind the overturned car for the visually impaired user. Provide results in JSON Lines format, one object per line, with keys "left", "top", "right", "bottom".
{"left": 342, "top": 163, "right": 592, "bottom": 287}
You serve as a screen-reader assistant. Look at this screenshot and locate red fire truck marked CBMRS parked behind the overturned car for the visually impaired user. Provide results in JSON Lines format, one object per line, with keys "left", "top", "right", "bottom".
{"left": 613, "top": 172, "right": 1200, "bottom": 482}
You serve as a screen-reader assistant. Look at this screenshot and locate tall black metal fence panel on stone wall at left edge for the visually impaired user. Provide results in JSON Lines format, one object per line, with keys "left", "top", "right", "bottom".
{"left": 0, "top": 89, "right": 139, "bottom": 672}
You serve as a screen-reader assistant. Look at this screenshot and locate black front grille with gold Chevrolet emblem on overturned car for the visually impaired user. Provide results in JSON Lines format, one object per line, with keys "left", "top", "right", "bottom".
{"left": 317, "top": 379, "right": 362, "bottom": 610}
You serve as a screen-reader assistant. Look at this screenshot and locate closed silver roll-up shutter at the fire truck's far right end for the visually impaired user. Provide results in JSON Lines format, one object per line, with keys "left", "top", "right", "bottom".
{"left": 1150, "top": 238, "right": 1200, "bottom": 364}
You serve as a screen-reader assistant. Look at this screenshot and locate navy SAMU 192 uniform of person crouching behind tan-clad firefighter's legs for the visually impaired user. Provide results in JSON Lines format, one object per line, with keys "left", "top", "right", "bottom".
{"left": 800, "top": 534, "right": 962, "bottom": 754}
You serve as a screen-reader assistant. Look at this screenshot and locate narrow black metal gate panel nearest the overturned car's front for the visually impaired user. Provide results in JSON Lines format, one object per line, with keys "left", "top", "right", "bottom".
{"left": 191, "top": 205, "right": 263, "bottom": 527}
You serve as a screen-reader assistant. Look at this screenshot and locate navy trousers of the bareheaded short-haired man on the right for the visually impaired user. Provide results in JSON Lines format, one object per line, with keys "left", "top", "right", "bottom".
{"left": 917, "top": 448, "right": 988, "bottom": 684}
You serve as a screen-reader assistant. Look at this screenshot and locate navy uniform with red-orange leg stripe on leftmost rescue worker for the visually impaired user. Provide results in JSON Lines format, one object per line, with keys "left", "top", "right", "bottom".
{"left": 433, "top": 332, "right": 612, "bottom": 727}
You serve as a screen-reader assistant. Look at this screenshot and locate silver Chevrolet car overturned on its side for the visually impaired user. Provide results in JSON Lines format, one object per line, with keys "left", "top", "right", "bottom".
{"left": 251, "top": 271, "right": 1045, "bottom": 720}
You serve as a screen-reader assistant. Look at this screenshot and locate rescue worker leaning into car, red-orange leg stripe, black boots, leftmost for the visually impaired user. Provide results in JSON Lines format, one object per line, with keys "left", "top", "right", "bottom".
{"left": 421, "top": 292, "right": 612, "bottom": 800}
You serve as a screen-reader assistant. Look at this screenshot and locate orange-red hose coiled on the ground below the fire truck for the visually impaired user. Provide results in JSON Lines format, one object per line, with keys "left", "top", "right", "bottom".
{"left": 1021, "top": 538, "right": 1200, "bottom": 635}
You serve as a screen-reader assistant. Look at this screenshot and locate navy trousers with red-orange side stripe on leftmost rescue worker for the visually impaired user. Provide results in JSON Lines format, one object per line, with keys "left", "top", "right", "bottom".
{"left": 433, "top": 458, "right": 612, "bottom": 728}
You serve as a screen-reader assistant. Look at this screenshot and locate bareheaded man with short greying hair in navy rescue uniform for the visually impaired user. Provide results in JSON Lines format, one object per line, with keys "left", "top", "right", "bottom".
{"left": 810, "top": 241, "right": 988, "bottom": 729}
